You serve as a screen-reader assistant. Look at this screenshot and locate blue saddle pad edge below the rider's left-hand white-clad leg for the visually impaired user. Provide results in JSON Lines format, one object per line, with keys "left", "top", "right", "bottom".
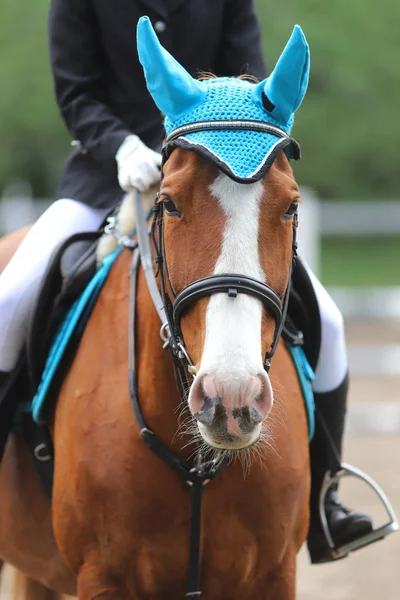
{"left": 31, "top": 248, "right": 121, "bottom": 425}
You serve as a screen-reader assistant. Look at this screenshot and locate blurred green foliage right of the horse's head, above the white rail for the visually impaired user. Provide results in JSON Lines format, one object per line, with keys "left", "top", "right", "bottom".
{"left": 258, "top": 0, "right": 400, "bottom": 199}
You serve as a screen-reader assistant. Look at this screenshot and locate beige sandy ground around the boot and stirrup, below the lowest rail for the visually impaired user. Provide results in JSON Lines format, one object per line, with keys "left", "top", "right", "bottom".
{"left": 298, "top": 435, "right": 400, "bottom": 600}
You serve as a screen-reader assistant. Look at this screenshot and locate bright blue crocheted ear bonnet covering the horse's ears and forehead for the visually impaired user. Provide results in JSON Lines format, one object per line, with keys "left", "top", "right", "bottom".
{"left": 137, "top": 17, "right": 309, "bottom": 183}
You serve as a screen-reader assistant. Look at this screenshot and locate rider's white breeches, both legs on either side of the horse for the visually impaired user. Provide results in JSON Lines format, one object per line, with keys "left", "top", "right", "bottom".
{"left": 0, "top": 199, "right": 347, "bottom": 392}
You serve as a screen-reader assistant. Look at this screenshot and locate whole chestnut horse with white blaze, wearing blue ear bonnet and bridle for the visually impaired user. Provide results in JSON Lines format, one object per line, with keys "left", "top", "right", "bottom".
{"left": 0, "top": 17, "right": 310, "bottom": 600}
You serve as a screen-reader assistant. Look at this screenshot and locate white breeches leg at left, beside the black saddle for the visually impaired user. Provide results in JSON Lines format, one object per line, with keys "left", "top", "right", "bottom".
{"left": 0, "top": 198, "right": 109, "bottom": 371}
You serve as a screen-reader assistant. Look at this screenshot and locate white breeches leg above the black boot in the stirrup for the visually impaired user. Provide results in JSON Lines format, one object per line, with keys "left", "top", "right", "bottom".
{"left": 303, "top": 261, "right": 348, "bottom": 393}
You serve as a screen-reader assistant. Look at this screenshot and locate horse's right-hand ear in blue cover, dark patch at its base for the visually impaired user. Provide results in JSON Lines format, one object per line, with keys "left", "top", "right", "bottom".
{"left": 253, "top": 25, "right": 310, "bottom": 125}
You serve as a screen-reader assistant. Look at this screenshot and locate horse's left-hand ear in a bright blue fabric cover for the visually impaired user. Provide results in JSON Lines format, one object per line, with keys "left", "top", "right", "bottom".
{"left": 137, "top": 17, "right": 207, "bottom": 120}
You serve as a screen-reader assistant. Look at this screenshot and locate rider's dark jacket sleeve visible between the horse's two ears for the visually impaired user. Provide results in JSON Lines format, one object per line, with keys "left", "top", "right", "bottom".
{"left": 215, "top": 0, "right": 267, "bottom": 79}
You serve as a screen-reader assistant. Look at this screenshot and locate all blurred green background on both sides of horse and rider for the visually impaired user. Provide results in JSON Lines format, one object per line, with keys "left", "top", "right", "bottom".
{"left": 0, "top": 0, "right": 400, "bottom": 285}
